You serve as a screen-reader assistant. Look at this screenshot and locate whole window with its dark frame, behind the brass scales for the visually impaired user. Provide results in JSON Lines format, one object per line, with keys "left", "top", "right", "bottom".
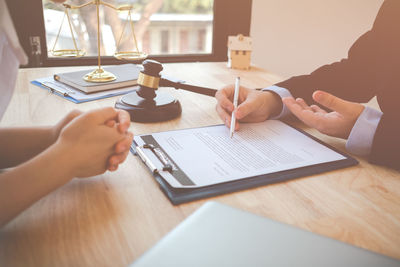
{"left": 6, "top": 0, "right": 251, "bottom": 67}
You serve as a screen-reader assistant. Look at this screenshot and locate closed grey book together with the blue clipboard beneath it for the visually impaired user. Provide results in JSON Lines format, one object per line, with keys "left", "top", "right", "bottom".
{"left": 32, "top": 64, "right": 140, "bottom": 103}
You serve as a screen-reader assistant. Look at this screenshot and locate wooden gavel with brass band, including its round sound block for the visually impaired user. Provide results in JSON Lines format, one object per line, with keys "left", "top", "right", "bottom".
{"left": 115, "top": 59, "right": 217, "bottom": 122}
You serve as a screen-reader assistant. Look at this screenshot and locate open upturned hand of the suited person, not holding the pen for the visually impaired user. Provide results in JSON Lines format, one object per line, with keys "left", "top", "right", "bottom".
{"left": 282, "top": 91, "right": 364, "bottom": 139}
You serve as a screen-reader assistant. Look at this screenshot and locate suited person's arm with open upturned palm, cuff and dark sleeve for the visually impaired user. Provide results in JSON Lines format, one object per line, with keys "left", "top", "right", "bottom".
{"left": 283, "top": 91, "right": 400, "bottom": 169}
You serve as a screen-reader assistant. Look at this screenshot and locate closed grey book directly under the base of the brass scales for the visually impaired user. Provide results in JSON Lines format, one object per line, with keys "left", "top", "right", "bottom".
{"left": 54, "top": 64, "right": 140, "bottom": 93}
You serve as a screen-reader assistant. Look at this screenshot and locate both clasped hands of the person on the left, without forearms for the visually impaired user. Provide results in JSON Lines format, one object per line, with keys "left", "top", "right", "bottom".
{"left": 53, "top": 108, "right": 133, "bottom": 177}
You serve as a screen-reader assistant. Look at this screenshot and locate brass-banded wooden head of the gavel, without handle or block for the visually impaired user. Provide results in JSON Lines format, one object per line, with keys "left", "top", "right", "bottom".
{"left": 137, "top": 59, "right": 163, "bottom": 101}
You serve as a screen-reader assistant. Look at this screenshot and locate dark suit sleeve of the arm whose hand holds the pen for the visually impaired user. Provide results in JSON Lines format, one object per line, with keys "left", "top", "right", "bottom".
{"left": 277, "top": 0, "right": 394, "bottom": 103}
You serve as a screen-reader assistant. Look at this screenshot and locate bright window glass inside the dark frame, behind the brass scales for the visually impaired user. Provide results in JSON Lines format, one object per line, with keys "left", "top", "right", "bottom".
{"left": 42, "top": 0, "right": 214, "bottom": 57}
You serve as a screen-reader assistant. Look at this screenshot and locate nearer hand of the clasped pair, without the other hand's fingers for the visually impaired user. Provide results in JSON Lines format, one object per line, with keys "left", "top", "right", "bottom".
{"left": 55, "top": 108, "right": 132, "bottom": 177}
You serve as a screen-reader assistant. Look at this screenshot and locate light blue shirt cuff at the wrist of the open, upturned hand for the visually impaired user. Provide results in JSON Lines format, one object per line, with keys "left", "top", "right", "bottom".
{"left": 346, "top": 107, "right": 383, "bottom": 156}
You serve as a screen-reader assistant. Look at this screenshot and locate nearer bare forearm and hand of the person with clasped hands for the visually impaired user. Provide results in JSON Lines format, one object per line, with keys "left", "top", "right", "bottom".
{"left": 0, "top": 108, "right": 133, "bottom": 227}
